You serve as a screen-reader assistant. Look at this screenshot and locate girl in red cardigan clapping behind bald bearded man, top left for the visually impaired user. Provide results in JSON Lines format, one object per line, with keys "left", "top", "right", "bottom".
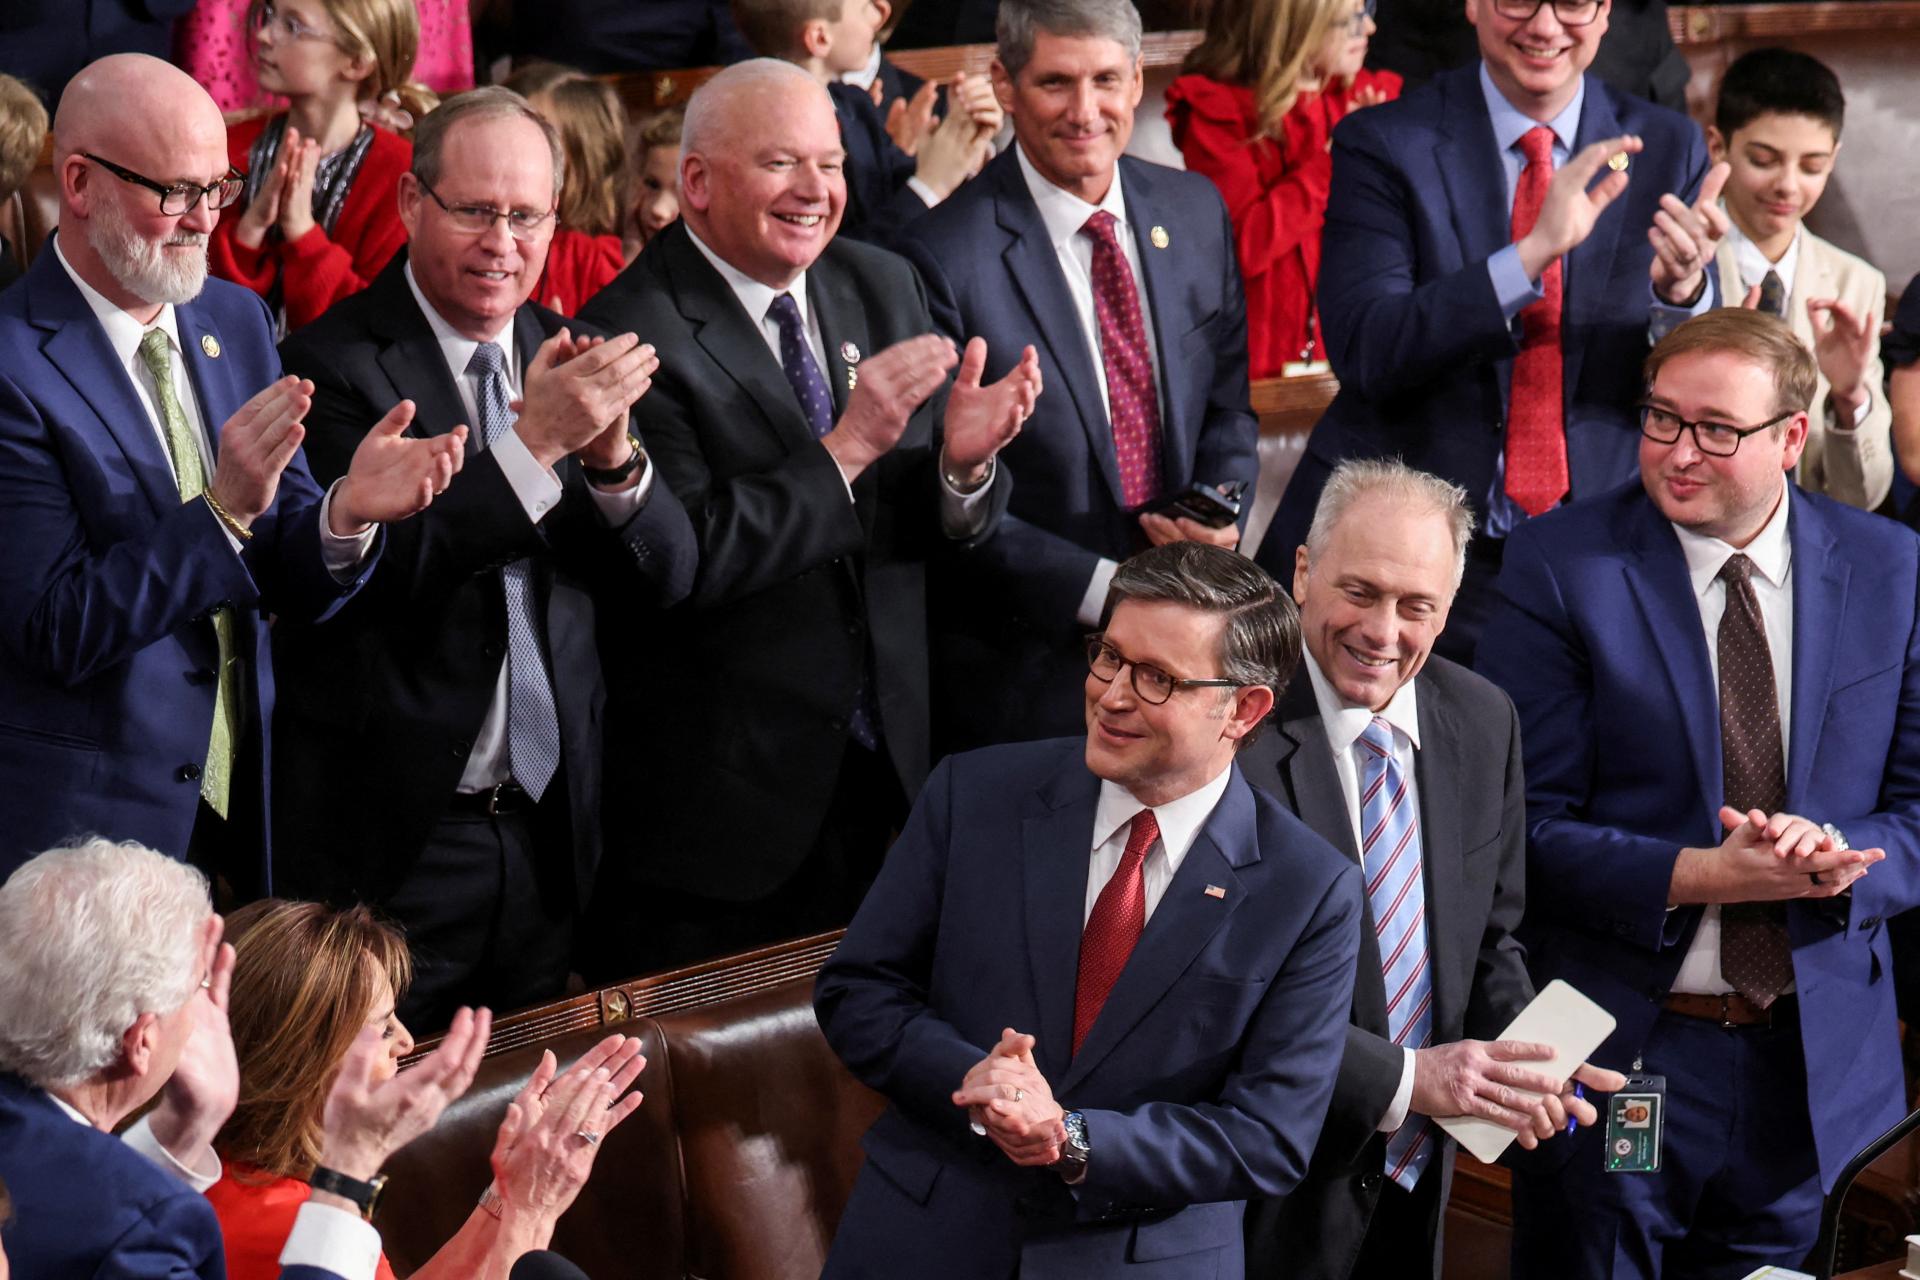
{"left": 209, "top": 0, "right": 432, "bottom": 332}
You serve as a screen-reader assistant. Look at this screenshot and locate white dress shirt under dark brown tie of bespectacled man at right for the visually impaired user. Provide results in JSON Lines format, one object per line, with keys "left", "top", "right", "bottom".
{"left": 1672, "top": 478, "right": 1793, "bottom": 996}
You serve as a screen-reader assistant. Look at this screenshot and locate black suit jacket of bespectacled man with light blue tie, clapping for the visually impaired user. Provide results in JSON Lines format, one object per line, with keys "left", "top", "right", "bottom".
{"left": 273, "top": 253, "right": 695, "bottom": 902}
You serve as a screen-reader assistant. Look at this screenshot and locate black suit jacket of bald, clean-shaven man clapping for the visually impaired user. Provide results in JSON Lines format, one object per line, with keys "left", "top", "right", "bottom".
{"left": 582, "top": 223, "right": 1010, "bottom": 902}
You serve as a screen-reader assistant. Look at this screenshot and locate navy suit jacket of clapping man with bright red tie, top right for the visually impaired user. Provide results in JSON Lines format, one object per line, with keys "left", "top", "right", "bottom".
{"left": 1260, "top": 61, "right": 1711, "bottom": 581}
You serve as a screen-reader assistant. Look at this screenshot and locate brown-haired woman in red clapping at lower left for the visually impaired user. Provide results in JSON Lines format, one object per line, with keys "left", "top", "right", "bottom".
{"left": 207, "top": 898, "right": 647, "bottom": 1280}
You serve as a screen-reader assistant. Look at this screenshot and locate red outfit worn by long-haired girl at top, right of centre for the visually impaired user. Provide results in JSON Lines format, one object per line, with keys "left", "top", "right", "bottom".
{"left": 1167, "top": 71, "right": 1400, "bottom": 378}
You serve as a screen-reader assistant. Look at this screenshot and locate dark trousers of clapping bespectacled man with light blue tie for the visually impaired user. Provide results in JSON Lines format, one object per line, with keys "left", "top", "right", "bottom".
{"left": 380, "top": 786, "right": 574, "bottom": 1038}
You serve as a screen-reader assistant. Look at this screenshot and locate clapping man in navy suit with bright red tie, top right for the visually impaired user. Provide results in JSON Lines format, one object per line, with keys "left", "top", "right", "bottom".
{"left": 1258, "top": 0, "right": 1726, "bottom": 660}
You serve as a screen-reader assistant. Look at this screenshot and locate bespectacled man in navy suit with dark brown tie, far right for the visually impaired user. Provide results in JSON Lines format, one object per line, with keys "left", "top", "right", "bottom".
{"left": 1480, "top": 309, "right": 1920, "bottom": 1280}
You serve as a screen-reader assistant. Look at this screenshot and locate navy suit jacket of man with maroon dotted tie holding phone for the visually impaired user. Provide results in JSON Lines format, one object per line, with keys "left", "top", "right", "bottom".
{"left": 899, "top": 148, "right": 1260, "bottom": 745}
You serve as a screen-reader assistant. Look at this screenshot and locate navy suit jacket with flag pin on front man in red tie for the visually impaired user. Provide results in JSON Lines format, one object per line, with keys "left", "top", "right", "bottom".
{"left": 814, "top": 739, "right": 1361, "bottom": 1280}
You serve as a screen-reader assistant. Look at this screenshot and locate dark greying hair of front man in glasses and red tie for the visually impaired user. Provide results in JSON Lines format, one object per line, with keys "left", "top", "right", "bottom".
{"left": 1100, "top": 543, "right": 1300, "bottom": 748}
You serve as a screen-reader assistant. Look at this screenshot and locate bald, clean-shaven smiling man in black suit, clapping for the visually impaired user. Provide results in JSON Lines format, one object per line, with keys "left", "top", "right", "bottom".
{"left": 582, "top": 59, "right": 1041, "bottom": 971}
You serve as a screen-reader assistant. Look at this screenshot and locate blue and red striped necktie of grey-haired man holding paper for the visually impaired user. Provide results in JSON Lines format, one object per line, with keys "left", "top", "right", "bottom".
{"left": 1359, "top": 716, "right": 1434, "bottom": 1192}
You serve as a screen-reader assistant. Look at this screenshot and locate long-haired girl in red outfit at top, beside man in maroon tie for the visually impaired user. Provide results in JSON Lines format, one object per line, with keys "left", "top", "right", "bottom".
{"left": 1167, "top": 0, "right": 1400, "bottom": 378}
